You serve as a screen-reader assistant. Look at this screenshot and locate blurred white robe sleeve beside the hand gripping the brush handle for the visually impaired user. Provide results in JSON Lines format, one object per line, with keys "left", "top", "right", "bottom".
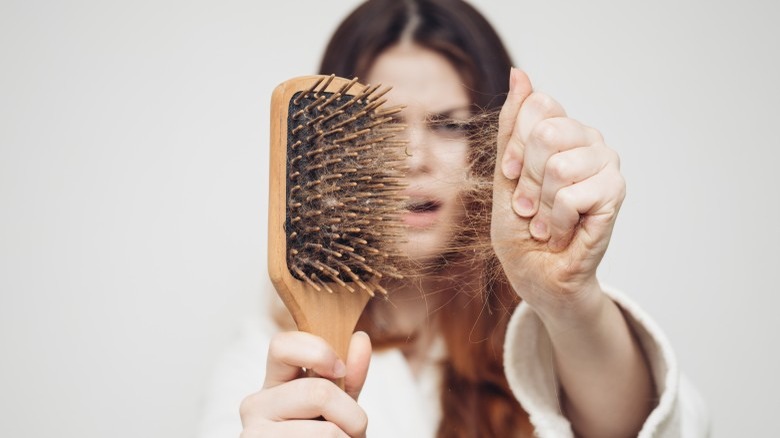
{"left": 198, "top": 318, "right": 276, "bottom": 438}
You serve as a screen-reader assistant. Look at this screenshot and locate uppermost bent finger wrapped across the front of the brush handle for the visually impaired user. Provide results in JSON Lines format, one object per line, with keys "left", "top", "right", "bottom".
{"left": 263, "top": 332, "right": 346, "bottom": 388}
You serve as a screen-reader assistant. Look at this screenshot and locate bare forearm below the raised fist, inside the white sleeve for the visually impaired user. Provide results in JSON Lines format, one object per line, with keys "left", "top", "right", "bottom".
{"left": 542, "top": 293, "right": 655, "bottom": 437}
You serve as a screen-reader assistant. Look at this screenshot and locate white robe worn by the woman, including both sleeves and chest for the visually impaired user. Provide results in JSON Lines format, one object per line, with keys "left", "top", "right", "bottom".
{"left": 199, "top": 289, "right": 709, "bottom": 438}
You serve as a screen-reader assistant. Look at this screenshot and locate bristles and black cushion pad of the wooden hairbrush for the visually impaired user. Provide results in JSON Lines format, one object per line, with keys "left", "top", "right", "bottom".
{"left": 285, "top": 76, "right": 405, "bottom": 295}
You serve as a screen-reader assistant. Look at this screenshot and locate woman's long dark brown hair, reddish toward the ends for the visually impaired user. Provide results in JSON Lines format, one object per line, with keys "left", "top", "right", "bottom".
{"left": 320, "top": 0, "right": 532, "bottom": 438}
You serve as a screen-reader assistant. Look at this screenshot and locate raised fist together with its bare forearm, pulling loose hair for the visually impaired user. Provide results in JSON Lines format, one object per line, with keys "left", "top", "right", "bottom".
{"left": 491, "top": 69, "right": 653, "bottom": 437}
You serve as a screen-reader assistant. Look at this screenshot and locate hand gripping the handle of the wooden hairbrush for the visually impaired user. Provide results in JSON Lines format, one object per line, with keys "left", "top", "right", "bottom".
{"left": 241, "top": 332, "right": 371, "bottom": 438}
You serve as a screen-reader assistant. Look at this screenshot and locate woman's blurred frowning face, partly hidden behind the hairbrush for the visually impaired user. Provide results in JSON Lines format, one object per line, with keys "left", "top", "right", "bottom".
{"left": 365, "top": 43, "right": 471, "bottom": 261}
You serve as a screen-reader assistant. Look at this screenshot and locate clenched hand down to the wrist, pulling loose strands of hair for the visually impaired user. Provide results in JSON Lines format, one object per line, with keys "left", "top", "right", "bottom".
{"left": 491, "top": 69, "right": 625, "bottom": 328}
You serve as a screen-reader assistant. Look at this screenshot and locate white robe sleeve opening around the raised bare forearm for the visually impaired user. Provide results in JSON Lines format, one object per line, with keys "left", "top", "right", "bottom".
{"left": 504, "top": 288, "right": 709, "bottom": 438}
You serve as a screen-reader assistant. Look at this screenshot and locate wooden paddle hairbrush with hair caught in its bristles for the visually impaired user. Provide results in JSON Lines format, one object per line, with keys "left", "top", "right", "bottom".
{"left": 268, "top": 76, "right": 405, "bottom": 384}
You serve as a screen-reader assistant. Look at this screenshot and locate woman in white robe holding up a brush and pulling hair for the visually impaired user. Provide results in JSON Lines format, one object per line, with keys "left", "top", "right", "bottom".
{"left": 200, "top": 0, "right": 706, "bottom": 437}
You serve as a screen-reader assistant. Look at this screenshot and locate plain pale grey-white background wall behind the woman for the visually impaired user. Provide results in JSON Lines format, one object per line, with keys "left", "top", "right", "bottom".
{"left": 0, "top": 0, "right": 780, "bottom": 437}
